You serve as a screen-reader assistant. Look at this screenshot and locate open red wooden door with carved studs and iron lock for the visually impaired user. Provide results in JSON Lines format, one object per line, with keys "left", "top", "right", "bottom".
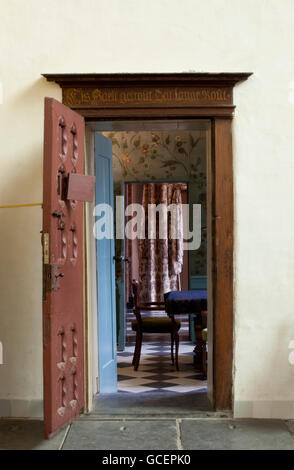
{"left": 42, "top": 98, "right": 87, "bottom": 438}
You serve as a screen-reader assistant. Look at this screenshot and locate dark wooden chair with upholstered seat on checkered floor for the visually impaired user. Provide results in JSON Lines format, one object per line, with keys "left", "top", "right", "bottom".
{"left": 132, "top": 281, "right": 181, "bottom": 370}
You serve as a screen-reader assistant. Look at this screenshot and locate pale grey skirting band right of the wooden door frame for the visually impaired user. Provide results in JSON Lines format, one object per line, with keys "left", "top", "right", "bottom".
{"left": 233, "top": 400, "right": 294, "bottom": 419}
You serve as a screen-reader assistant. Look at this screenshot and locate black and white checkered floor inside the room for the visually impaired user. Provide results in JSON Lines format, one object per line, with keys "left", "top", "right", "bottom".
{"left": 117, "top": 342, "right": 207, "bottom": 393}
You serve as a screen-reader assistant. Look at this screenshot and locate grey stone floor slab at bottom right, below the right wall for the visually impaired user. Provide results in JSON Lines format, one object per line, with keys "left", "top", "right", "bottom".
{"left": 181, "top": 419, "right": 294, "bottom": 450}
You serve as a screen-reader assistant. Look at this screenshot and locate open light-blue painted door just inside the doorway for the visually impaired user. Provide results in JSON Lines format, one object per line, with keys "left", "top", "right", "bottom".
{"left": 94, "top": 132, "right": 117, "bottom": 393}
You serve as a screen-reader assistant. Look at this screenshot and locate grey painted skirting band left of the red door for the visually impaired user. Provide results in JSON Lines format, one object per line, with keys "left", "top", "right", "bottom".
{"left": 0, "top": 399, "right": 43, "bottom": 419}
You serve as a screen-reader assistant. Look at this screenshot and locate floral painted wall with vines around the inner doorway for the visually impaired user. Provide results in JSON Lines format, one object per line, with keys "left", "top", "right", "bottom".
{"left": 103, "top": 130, "right": 206, "bottom": 276}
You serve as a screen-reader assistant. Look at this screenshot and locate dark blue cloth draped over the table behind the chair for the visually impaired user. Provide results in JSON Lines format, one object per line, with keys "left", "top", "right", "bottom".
{"left": 164, "top": 290, "right": 207, "bottom": 315}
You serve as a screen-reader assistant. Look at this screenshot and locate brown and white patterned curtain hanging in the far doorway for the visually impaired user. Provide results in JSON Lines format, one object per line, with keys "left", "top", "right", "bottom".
{"left": 139, "top": 183, "right": 183, "bottom": 302}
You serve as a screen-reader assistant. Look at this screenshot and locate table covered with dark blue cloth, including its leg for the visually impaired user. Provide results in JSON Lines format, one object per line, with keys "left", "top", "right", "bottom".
{"left": 164, "top": 289, "right": 207, "bottom": 372}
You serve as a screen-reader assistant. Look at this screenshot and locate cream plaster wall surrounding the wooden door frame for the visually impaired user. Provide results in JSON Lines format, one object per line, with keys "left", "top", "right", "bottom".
{"left": 0, "top": 0, "right": 294, "bottom": 418}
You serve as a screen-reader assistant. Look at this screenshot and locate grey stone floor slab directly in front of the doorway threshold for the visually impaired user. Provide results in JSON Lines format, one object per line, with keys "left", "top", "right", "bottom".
{"left": 63, "top": 420, "right": 177, "bottom": 450}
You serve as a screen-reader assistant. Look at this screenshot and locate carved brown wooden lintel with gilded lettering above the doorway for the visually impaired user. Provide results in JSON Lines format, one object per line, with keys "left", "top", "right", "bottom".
{"left": 44, "top": 73, "right": 251, "bottom": 118}
